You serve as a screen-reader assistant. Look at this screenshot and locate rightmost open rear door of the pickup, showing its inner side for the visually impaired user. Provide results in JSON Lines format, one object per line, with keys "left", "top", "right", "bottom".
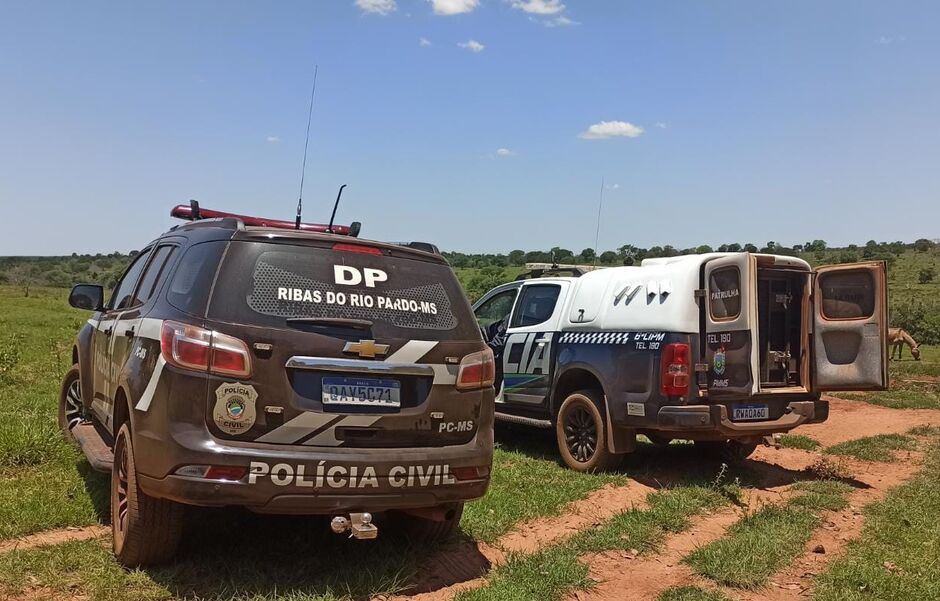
{"left": 813, "top": 261, "right": 888, "bottom": 391}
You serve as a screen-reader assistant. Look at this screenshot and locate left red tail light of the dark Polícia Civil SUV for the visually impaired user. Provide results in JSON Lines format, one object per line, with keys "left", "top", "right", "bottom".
{"left": 160, "top": 321, "right": 251, "bottom": 378}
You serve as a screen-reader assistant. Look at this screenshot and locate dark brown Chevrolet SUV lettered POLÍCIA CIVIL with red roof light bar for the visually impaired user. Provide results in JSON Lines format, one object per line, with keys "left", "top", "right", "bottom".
{"left": 59, "top": 205, "right": 494, "bottom": 565}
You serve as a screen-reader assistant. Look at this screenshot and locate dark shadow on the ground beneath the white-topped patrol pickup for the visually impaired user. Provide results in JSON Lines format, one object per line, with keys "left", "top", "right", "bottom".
{"left": 496, "top": 423, "right": 869, "bottom": 489}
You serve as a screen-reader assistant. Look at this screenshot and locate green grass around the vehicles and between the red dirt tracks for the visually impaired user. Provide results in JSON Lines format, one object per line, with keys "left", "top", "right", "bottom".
{"left": 0, "top": 287, "right": 940, "bottom": 601}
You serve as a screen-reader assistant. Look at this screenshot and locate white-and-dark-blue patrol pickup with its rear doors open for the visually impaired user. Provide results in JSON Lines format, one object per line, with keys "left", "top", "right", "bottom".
{"left": 474, "top": 253, "right": 888, "bottom": 471}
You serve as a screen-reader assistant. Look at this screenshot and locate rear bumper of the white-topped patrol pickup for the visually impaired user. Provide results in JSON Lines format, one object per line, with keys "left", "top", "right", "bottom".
{"left": 657, "top": 400, "right": 829, "bottom": 438}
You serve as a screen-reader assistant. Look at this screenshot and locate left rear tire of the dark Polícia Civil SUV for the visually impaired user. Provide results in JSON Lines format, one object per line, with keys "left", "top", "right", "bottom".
{"left": 111, "top": 423, "right": 183, "bottom": 568}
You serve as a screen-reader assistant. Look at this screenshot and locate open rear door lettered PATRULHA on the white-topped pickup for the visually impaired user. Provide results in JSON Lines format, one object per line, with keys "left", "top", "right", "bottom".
{"left": 704, "top": 253, "right": 758, "bottom": 399}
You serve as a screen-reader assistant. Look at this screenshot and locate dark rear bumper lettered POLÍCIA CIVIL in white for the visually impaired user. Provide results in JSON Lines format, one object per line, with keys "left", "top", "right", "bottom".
{"left": 134, "top": 428, "right": 493, "bottom": 514}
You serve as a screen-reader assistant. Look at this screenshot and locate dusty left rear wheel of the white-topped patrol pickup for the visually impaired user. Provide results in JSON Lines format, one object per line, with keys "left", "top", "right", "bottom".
{"left": 555, "top": 390, "right": 623, "bottom": 472}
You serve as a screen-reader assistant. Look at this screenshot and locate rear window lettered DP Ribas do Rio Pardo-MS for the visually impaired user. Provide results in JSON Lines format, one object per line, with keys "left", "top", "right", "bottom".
{"left": 209, "top": 242, "right": 479, "bottom": 340}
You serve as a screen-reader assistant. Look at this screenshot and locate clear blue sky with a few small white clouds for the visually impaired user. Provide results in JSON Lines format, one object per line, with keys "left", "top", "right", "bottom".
{"left": 0, "top": 0, "right": 940, "bottom": 255}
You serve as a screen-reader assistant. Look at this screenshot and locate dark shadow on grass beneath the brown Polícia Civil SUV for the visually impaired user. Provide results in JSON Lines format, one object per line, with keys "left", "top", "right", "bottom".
{"left": 146, "top": 508, "right": 490, "bottom": 601}
